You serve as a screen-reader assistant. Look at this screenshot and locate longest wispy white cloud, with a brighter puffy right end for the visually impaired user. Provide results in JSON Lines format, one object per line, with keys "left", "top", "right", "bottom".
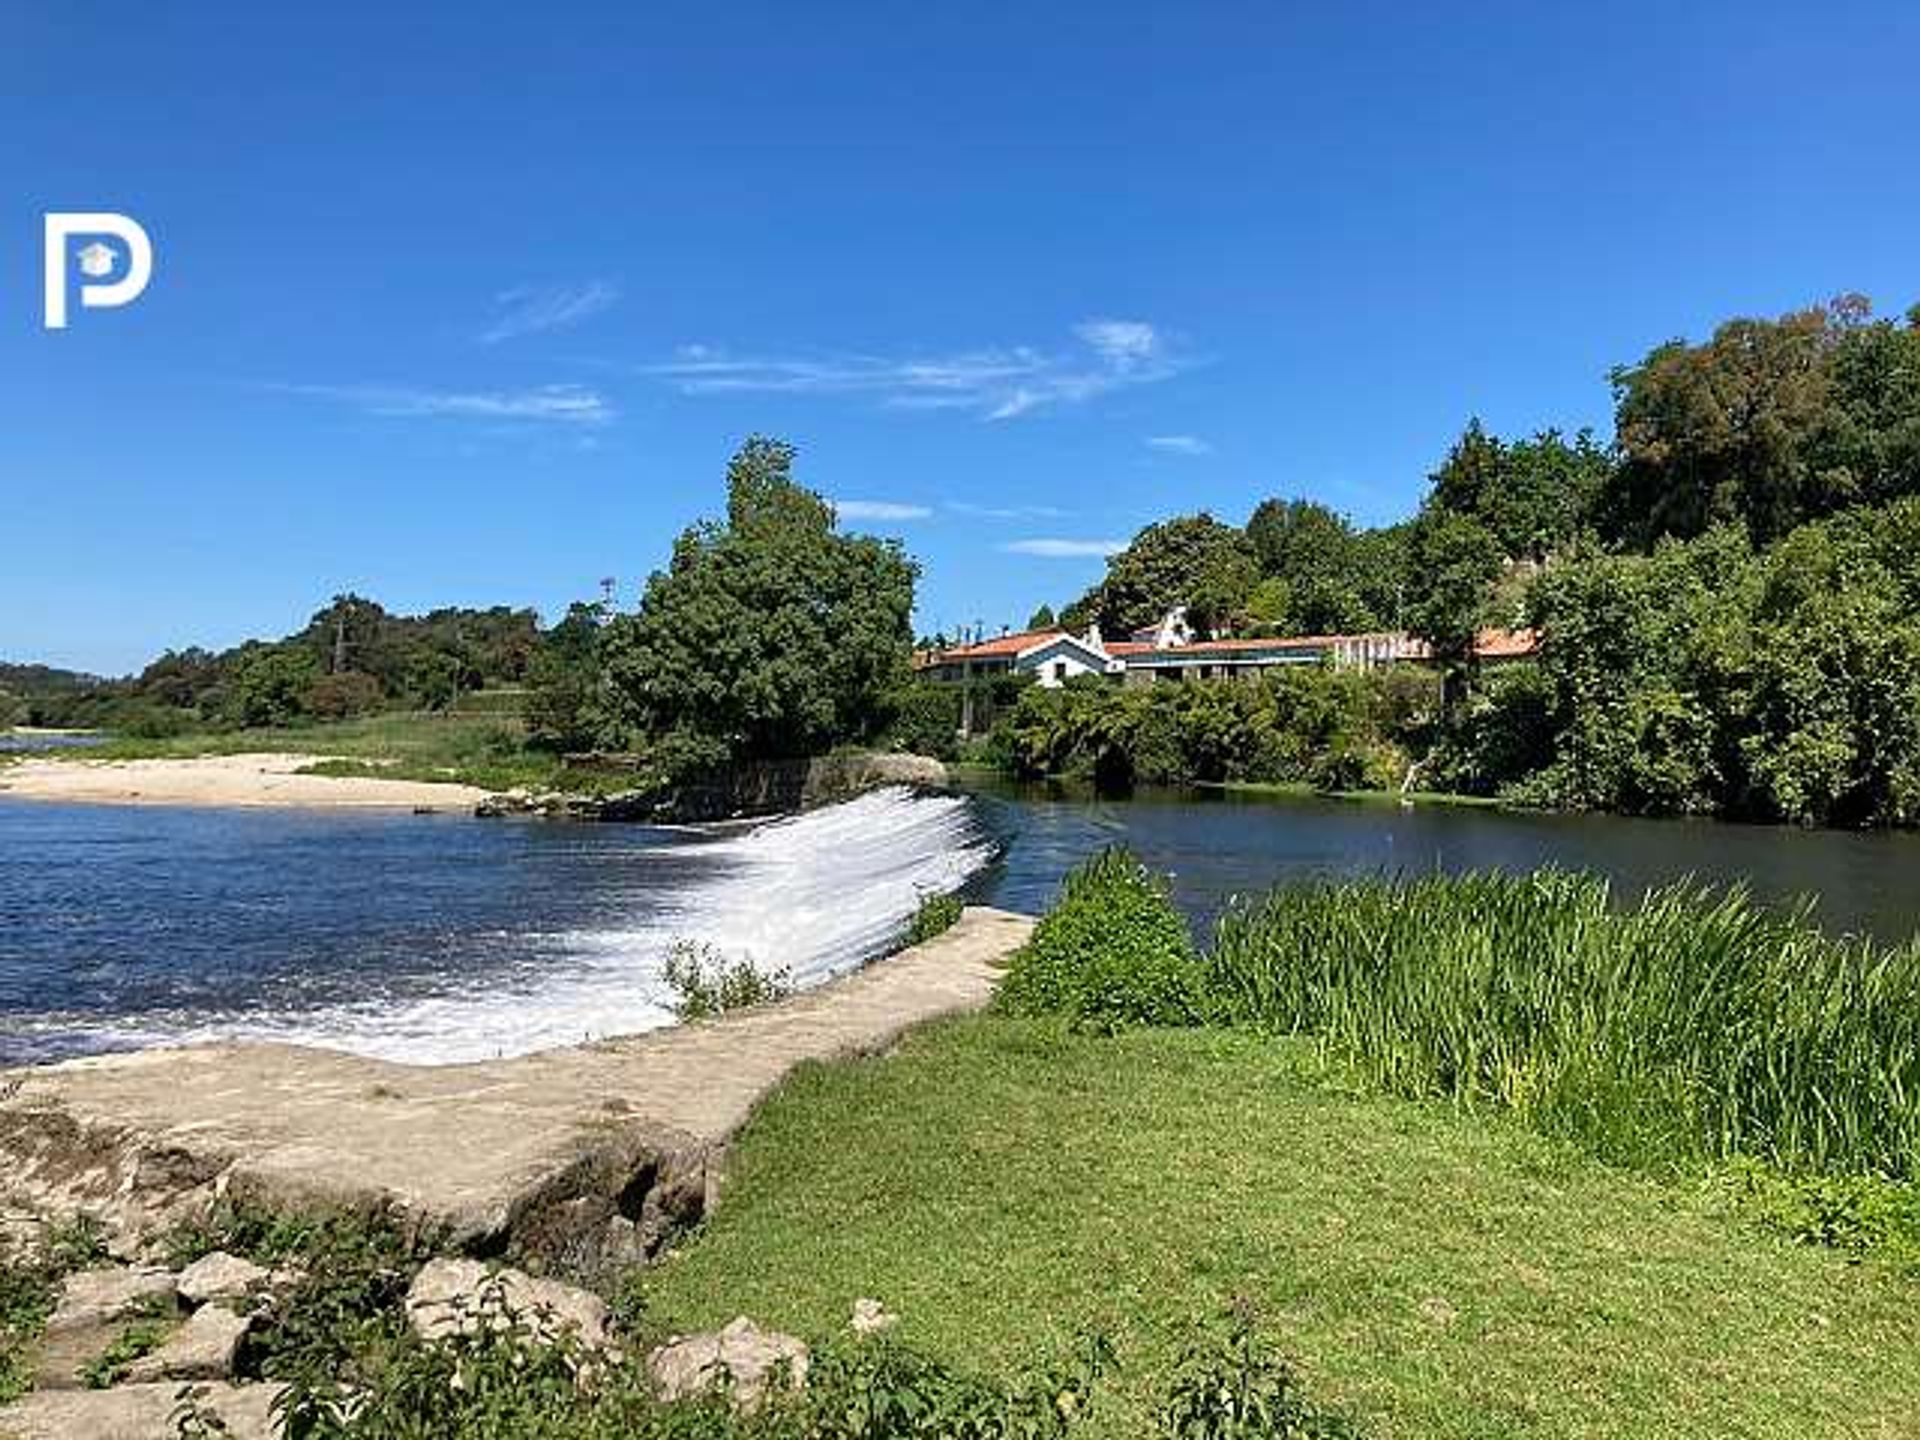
{"left": 637, "top": 321, "right": 1192, "bottom": 420}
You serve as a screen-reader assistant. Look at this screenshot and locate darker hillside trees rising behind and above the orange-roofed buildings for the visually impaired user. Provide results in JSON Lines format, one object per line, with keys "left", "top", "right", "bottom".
{"left": 1062, "top": 296, "right": 1920, "bottom": 639}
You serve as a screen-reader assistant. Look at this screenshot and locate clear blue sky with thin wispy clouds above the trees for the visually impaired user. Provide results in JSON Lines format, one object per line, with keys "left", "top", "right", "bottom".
{"left": 0, "top": 0, "right": 1920, "bottom": 672}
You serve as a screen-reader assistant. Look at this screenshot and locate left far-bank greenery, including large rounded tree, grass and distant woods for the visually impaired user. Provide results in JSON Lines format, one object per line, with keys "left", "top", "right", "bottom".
{"left": 0, "top": 438, "right": 936, "bottom": 802}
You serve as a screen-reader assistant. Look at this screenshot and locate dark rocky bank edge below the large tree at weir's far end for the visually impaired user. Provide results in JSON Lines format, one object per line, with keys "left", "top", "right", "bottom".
{"left": 474, "top": 753, "right": 948, "bottom": 824}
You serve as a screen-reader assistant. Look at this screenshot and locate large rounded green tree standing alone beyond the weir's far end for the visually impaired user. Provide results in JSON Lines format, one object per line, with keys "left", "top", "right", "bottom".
{"left": 601, "top": 436, "right": 916, "bottom": 756}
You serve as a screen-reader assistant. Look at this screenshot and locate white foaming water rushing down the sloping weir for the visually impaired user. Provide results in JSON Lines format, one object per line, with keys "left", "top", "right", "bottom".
{"left": 99, "top": 789, "right": 993, "bottom": 1064}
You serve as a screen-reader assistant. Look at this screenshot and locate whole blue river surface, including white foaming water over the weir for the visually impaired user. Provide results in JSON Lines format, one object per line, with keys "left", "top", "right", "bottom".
{"left": 0, "top": 787, "right": 1920, "bottom": 1064}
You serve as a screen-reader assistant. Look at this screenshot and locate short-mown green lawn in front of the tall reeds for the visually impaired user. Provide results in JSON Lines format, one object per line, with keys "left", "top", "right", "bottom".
{"left": 645, "top": 1018, "right": 1920, "bottom": 1440}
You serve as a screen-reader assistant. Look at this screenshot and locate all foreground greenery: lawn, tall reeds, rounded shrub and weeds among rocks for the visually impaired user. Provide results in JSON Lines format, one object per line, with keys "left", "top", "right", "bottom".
{"left": 15, "top": 864, "right": 1920, "bottom": 1440}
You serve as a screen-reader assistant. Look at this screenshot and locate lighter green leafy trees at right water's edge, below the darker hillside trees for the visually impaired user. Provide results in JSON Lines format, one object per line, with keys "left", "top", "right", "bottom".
{"left": 1453, "top": 497, "right": 1920, "bottom": 826}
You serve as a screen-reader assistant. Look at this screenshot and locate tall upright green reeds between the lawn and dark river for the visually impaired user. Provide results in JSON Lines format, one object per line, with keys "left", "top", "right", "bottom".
{"left": 1202, "top": 870, "right": 1920, "bottom": 1179}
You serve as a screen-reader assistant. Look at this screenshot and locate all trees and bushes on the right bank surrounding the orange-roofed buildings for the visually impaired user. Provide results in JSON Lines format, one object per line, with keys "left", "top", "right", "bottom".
{"left": 1000, "top": 296, "right": 1920, "bottom": 824}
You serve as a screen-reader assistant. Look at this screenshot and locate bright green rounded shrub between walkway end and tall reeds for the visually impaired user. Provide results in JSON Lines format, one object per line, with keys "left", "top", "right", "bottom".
{"left": 996, "top": 849, "right": 1202, "bottom": 1031}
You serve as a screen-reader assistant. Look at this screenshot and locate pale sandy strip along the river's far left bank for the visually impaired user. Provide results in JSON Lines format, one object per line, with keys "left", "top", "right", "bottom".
{"left": 0, "top": 755, "right": 486, "bottom": 810}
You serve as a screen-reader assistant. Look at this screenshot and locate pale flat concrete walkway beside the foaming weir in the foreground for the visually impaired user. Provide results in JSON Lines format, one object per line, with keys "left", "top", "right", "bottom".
{"left": 0, "top": 908, "right": 1033, "bottom": 1263}
